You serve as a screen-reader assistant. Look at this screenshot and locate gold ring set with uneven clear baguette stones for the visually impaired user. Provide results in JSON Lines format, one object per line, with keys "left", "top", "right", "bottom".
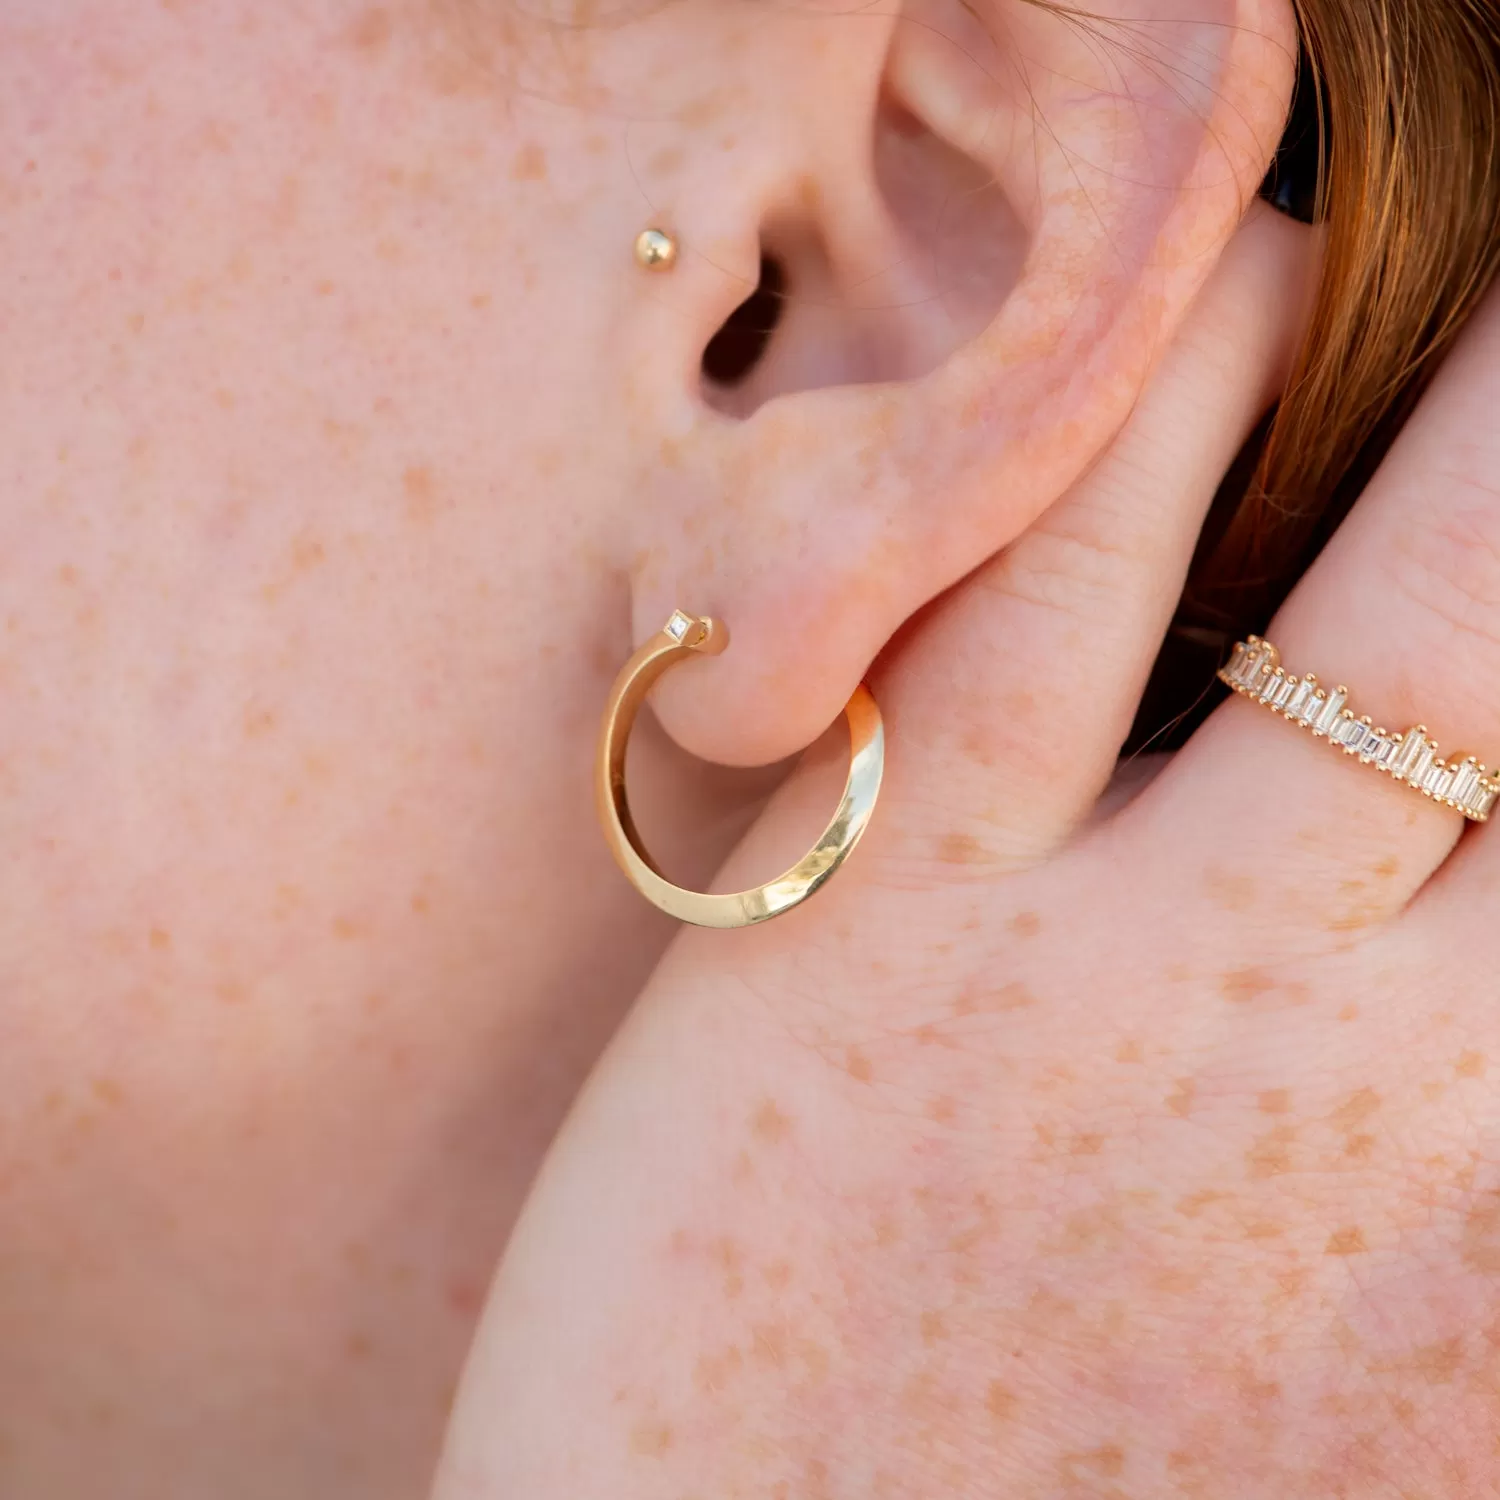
{"left": 1218, "top": 636, "right": 1500, "bottom": 824}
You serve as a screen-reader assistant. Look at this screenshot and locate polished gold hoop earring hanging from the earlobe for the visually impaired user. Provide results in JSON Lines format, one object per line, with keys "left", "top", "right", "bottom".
{"left": 594, "top": 611, "right": 885, "bottom": 929}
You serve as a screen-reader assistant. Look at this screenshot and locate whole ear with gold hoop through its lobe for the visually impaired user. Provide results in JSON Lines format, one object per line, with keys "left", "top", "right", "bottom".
{"left": 623, "top": 0, "right": 1296, "bottom": 765}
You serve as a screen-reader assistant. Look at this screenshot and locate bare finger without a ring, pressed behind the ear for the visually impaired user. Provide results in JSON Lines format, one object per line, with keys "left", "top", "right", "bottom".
{"left": 876, "top": 210, "right": 1316, "bottom": 866}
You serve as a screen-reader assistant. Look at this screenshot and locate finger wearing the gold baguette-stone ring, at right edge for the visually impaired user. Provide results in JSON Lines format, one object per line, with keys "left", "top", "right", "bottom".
{"left": 1152, "top": 273, "right": 1500, "bottom": 932}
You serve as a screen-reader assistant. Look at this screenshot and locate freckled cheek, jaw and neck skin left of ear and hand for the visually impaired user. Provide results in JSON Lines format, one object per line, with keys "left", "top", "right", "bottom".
{"left": 0, "top": 0, "right": 810, "bottom": 1500}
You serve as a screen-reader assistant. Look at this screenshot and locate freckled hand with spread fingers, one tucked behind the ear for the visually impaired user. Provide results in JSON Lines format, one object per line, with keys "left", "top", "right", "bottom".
{"left": 437, "top": 216, "right": 1500, "bottom": 1500}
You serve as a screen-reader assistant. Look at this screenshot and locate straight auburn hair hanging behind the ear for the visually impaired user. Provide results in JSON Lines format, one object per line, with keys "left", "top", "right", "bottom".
{"left": 1133, "top": 0, "right": 1500, "bottom": 749}
